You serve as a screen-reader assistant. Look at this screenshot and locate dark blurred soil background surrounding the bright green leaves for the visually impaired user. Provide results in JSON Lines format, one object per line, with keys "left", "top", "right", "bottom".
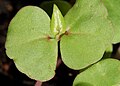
{"left": 0, "top": 0, "right": 120, "bottom": 86}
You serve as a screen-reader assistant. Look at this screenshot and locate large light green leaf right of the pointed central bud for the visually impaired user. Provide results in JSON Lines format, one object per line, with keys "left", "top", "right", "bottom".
{"left": 60, "top": 0, "right": 113, "bottom": 69}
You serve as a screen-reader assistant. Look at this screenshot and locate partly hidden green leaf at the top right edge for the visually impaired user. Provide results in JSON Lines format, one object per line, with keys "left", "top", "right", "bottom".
{"left": 102, "top": 0, "right": 120, "bottom": 44}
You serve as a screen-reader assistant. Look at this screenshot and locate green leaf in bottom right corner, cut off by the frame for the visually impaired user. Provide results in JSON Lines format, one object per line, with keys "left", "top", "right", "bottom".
{"left": 73, "top": 59, "right": 120, "bottom": 86}
